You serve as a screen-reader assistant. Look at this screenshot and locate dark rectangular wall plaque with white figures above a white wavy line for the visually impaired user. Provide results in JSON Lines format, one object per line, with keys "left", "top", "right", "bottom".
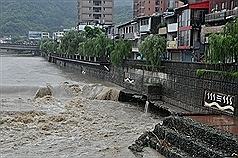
{"left": 204, "top": 90, "right": 235, "bottom": 114}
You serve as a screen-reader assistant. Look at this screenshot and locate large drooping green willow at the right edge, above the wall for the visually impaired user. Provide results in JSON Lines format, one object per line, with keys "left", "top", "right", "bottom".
{"left": 205, "top": 19, "right": 238, "bottom": 63}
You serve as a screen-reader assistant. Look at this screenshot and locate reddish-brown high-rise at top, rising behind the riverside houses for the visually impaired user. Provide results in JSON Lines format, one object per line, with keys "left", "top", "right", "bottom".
{"left": 133, "top": 0, "right": 183, "bottom": 18}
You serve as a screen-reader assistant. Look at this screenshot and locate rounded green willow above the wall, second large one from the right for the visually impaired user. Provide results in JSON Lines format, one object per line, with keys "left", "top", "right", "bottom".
{"left": 139, "top": 35, "right": 166, "bottom": 68}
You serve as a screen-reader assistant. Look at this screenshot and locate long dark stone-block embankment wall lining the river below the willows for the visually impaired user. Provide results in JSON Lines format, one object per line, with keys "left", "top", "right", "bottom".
{"left": 43, "top": 54, "right": 238, "bottom": 116}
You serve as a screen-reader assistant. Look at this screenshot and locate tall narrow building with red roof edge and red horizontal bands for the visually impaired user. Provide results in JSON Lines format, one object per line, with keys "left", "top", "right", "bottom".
{"left": 175, "top": 1, "right": 209, "bottom": 61}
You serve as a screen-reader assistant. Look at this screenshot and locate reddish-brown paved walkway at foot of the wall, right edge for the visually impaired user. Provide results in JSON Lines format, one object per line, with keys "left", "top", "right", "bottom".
{"left": 187, "top": 115, "right": 238, "bottom": 135}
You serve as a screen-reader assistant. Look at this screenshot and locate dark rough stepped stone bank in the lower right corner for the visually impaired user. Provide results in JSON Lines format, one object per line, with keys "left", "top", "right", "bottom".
{"left": 129, "top": 116, "right": 238, "bottom": 158}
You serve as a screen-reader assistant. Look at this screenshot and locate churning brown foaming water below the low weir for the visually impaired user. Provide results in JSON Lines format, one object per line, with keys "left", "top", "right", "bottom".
{"left": 0, "top": 82, "right": 163, "bottom": 158}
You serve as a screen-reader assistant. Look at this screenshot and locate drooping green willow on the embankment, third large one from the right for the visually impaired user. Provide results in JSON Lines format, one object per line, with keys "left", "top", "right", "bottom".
{"left": 110, "top": 40, "right": 132, "bottom": 67}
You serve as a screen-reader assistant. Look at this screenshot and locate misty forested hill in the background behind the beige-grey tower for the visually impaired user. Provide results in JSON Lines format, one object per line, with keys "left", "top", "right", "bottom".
{"left": 0, "top": 0, "right": 133, "bottom": 37}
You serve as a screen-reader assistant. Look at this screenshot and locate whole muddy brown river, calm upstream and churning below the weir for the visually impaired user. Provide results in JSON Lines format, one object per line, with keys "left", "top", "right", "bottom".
{"left": 0, "top": 54, "right": 165, "bottom": 158}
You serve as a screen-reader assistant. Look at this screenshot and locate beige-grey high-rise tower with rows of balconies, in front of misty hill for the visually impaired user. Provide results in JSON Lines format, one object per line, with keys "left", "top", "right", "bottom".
{"left": 78, "top": 0, "right": 114, "bottom": 25}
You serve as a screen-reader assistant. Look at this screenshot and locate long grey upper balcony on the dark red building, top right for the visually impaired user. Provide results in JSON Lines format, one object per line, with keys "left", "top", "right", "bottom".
{"left": 205, "top": 7, "right": 238, "bottom": 22}
